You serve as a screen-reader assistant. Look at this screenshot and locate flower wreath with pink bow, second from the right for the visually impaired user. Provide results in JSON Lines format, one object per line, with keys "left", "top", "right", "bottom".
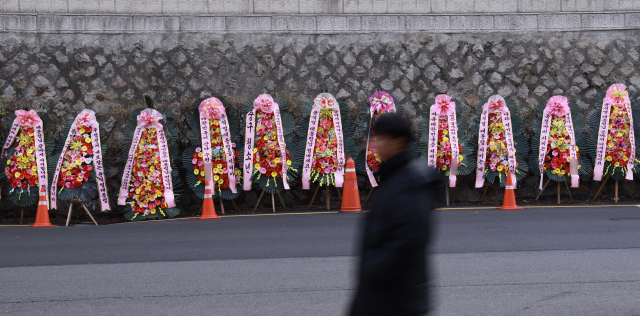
{"left": 530, "top": 96, "right": 588, "bottom": 190}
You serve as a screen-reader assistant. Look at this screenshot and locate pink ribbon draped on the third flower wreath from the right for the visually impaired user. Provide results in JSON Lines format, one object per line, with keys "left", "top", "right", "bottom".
{"left": 476, "top": 95, "right": 517, "bottom": 189}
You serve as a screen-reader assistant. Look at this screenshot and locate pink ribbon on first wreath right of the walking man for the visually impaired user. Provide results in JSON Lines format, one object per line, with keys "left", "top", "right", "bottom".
{"left": 427, "top": 94, "right": 459, "bottom": 188}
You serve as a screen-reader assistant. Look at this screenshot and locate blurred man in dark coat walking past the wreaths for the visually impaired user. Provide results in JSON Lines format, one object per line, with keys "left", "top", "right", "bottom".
{"left": 350, "top": 113, "right": 443, "bottom": 316}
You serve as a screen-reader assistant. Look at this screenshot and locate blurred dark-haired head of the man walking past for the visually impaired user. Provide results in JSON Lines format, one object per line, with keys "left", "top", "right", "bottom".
{"left": 371, "top": 113, "right": 411, "bottom": 160}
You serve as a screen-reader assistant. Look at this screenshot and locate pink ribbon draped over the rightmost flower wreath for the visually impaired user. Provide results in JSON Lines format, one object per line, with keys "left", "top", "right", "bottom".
{"left": 593, "top": 83, "right": 636, "bottom": 181}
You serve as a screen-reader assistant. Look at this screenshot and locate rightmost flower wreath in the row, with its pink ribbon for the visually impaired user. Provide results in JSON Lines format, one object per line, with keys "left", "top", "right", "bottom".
{"left": 589, "top": 84, "right": 640, "bottom": 181}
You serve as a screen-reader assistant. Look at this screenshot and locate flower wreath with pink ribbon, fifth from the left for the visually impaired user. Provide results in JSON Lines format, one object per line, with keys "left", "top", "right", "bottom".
{"left": 243, "top": 94, "right": 296, "bottom": 193}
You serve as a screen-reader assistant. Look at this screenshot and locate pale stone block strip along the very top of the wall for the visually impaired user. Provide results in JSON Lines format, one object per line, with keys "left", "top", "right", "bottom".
{"left": 0, "top": 0, "right": 640, "bottom": 14}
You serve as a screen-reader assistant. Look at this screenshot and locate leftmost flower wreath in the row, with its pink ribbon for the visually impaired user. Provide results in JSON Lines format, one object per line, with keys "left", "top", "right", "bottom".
{"left": 0, "top": 110, "right": 51, "bottom": 207}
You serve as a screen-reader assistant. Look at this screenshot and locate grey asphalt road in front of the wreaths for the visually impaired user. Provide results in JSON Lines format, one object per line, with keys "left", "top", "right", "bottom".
{"left": 0, "top": 206, "right": 640, "bottom": 315}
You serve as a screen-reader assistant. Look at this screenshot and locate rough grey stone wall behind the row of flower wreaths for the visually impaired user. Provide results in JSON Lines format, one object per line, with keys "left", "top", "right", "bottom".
{"left": 0, "top": 12, "right": 640, "bottom": 211}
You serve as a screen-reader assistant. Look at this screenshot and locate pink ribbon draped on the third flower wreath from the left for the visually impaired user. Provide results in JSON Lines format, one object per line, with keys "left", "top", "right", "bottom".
{"left": 118, "top": 109, "right": 176, "bottom": 208}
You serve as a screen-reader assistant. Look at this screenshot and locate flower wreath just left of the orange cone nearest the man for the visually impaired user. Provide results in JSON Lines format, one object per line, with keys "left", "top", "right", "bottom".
{"left": 302, "top": 93, "right": 345, "bottom": 190}
